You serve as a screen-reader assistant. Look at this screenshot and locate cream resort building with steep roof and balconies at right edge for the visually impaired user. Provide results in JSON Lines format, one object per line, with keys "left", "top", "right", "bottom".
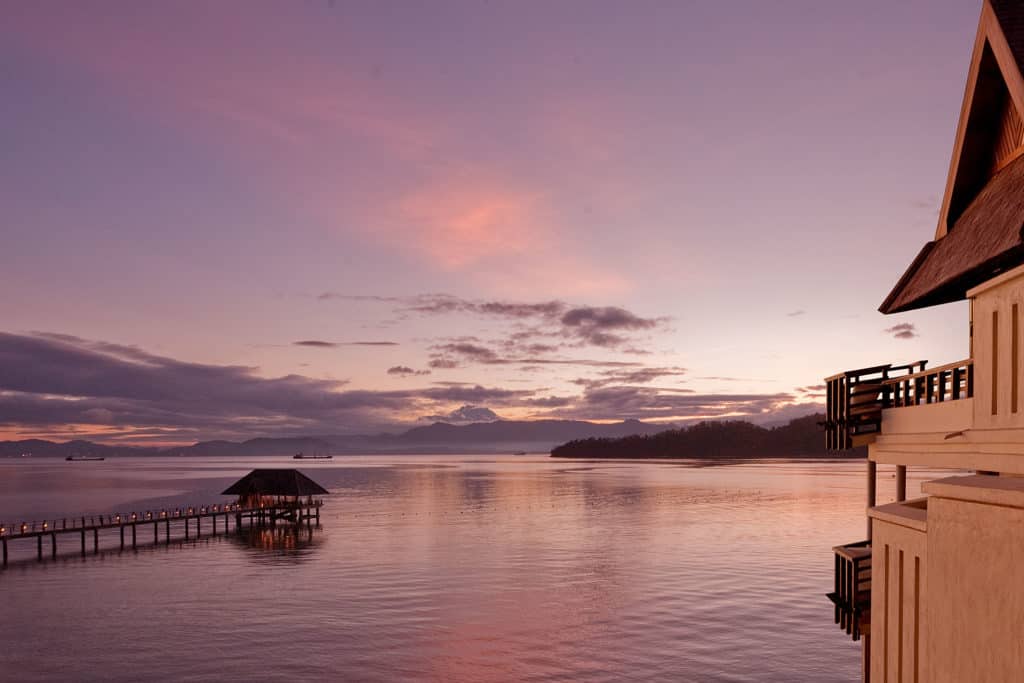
{"left": 825, "top": 0, "right": 1024, "bottom": 683}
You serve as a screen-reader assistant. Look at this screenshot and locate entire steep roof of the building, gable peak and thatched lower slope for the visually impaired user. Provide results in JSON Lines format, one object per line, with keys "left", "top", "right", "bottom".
{"left": 879, "top": 0, "right": 1024, "bottom": 313}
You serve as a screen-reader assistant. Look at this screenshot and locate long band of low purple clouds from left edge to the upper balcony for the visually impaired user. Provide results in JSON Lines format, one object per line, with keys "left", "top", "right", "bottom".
{"left": 0, "top": 333, "right": 817, "bottom": 443}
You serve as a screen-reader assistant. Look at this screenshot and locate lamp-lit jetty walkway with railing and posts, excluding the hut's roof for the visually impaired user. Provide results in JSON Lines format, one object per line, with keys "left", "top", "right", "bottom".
{"left": 0, "top": 497, "right": 324, "bottom": 567}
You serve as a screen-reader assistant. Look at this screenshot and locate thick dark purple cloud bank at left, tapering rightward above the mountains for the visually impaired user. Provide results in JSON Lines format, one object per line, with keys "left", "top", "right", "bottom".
{"left": 0, "top": 333, "right": 536, "bottom": 440}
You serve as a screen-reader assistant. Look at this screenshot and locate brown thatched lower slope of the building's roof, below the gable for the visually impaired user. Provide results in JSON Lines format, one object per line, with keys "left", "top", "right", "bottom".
{"left": 879, "top": 151, "right": 1024, "bottom": 313}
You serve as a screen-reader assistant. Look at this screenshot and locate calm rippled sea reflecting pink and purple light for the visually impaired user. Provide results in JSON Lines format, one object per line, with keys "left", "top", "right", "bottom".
{"left": 0, "top": 456, "right": 929, "bottom": 683}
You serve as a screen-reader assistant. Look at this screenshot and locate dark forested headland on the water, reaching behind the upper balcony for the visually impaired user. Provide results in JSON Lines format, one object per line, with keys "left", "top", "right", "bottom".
{"left": 551, "top": 415, "right": 864, "bottom": 459}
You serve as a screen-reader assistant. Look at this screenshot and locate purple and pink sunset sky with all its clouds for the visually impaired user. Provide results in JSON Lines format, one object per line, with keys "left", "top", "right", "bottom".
{"left": 0, "top": 0, "right": 980, "bottom": 444}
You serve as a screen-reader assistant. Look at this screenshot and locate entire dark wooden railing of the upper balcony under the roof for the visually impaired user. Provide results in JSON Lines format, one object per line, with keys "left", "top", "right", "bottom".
{"left": 824, "top": 358, "right": 974, "bottom": 451}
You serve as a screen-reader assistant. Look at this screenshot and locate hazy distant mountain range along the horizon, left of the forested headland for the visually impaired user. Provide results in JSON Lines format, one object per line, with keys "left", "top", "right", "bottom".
{"left": 0, "top": 420, "right": 666, "bottom": 458}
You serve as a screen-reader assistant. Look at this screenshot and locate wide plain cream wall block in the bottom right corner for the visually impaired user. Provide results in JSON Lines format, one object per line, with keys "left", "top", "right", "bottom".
{"left": 925, "top": 476, "right": 1024, "bottom": 683}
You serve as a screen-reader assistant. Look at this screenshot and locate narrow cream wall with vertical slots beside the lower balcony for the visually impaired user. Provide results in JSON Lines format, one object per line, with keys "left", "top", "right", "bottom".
{"left": 870, "top": 518, "right": 925, "bottom": 683}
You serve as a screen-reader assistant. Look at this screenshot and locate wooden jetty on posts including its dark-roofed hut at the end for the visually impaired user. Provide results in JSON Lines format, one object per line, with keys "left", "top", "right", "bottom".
{"left": 0, "top": 469, "right": 329, "bottom": 567}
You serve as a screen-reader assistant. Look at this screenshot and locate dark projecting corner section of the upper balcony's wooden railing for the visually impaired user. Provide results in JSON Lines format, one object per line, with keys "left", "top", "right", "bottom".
{"left": 824, "top": 360, "right": 928, "bottom": 451}
